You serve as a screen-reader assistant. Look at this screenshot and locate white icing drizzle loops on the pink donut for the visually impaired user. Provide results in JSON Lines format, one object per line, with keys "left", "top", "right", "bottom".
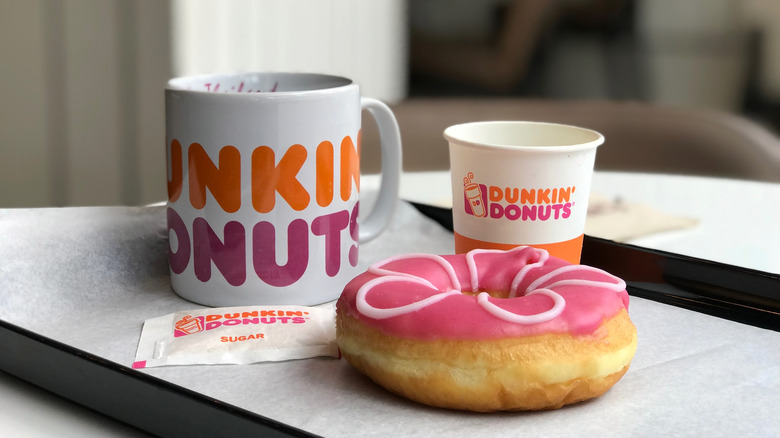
{"left": 356, "top": 246, "right": 626, "bottom": 324}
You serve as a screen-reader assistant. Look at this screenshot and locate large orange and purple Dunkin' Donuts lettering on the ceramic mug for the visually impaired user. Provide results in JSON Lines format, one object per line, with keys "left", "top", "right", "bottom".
{"left": 167, "top": 132, "right": 360, "bottom": 287}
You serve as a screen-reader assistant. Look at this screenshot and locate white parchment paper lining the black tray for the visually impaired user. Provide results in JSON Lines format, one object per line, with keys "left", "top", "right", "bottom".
{"left": 0, "top": 203, "right": 780, "bottom": 437}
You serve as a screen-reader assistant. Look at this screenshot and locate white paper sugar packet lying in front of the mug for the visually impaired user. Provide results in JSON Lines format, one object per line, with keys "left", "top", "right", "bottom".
{"left": 133, "top": 305, "right": 339, "bottom": 368}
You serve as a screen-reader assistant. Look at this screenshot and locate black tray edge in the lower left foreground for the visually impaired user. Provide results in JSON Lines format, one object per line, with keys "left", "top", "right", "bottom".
{"left": 0, "top": 320, "right": 316, "bottom": 437}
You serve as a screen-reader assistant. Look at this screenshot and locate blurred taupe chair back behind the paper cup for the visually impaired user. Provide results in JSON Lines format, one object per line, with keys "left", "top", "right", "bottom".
{"left": 361, "top": 98, "right": 780, "bottom": 182}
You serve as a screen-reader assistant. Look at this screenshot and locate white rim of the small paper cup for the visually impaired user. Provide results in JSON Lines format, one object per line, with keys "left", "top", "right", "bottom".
{"left": 443, "top": 120, "right": 604, "bottom": 153}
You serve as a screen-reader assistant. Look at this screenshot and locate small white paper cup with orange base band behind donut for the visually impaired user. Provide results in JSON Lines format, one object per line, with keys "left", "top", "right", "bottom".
{"left": 444, "top": 121, "right": 604, "bottom": 263}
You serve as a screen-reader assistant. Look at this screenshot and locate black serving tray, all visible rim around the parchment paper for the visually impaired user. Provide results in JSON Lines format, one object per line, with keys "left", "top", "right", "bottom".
{"left": 0, "top": 204, "right": 780, "bottom": 437}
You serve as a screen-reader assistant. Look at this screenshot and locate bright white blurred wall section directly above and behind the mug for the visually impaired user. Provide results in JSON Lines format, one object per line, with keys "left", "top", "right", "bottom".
{"left": 172, "top": 0, "right": 407, "bottom": 103}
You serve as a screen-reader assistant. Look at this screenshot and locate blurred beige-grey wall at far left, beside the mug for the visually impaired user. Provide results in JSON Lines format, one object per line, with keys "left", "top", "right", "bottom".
{"left": 0, "top": 0, "right": 171, "bottom": 207}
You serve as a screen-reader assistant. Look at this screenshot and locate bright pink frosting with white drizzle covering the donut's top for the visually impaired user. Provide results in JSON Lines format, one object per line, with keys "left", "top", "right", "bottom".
{"left": 338, "top": 247, "right": 628, "bottom": 340}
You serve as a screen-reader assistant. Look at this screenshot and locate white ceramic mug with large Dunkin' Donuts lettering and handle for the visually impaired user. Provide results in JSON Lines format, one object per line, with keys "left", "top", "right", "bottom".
{"left": 165, "top": 73, "right": 401, "bottom": 306}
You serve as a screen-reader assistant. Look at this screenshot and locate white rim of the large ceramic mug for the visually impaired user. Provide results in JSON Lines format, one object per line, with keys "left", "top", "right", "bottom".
{"left": 165, "top": 71, "right": 357, "bottom": 98}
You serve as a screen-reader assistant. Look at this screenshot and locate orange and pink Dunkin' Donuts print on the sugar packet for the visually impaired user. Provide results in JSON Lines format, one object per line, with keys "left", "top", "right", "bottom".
{"left": 173, "top": 310, "right": 311, "bottom": 342}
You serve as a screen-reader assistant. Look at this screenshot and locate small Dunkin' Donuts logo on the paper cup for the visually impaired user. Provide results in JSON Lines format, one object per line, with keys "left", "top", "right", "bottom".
{"left": 463, "top": 172, "right": 577, "bottom": 221}
